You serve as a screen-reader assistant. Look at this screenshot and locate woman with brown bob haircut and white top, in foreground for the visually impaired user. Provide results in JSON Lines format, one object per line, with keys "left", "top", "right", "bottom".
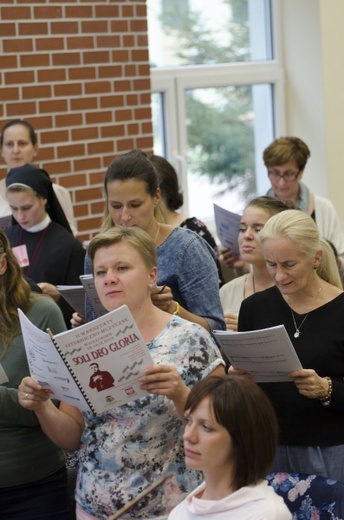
{"left": 168, "top": 375, "right": 292, "bottom": 520}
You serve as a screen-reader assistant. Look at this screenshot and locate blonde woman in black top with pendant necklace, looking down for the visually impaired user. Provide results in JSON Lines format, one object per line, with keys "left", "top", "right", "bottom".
{"left": 238, "top": 210, "right": 344, "bottom": 482}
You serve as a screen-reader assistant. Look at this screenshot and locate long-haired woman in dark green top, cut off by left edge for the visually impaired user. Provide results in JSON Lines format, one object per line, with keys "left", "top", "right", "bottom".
{"left": 0, "top": 230, "right": 72, "bottom": 520}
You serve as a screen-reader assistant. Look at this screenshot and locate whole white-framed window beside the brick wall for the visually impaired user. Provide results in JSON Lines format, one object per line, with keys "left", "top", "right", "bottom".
{"left": 147, "top": 0, "right": 284, "bottom": 223}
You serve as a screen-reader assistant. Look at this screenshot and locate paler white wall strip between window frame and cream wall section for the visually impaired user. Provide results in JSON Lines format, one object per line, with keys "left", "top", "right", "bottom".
{"left": 281, "top": 0, "right": 327, "bottom": 196}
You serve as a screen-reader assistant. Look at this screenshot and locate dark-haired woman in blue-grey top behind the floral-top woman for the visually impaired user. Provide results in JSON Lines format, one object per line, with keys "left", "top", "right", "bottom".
{"left": 73, "top": 150, "right": 225, "bottom": 332}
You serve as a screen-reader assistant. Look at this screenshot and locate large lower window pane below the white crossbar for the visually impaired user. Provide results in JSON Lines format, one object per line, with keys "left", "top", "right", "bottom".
{"left": 185, "top": 85, "right": 272, "bottom": 218}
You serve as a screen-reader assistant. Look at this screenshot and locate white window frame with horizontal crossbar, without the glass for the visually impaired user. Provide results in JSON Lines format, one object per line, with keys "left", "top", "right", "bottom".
{"left": 151, "top": 0, "right": 286, "bottom": 217}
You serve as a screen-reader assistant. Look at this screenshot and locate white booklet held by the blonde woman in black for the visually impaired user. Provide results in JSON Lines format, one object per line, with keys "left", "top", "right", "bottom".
{"left": 213, "top": 325, "right": 302, "bottom": 383}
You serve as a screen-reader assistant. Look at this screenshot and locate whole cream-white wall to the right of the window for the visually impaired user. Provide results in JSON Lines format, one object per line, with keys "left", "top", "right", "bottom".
{"left": 280, "top": 0, "right": 344, "bottom": 223}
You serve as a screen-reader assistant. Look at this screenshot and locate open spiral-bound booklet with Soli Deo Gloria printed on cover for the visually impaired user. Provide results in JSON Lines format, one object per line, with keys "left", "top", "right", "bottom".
{"left": 18, "top": 305, "right": 154, "bottom": 414}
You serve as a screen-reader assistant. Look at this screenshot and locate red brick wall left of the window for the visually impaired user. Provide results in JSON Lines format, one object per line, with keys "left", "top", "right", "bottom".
{"left": 0, "top": 0, "right": 153, "bottom": 240}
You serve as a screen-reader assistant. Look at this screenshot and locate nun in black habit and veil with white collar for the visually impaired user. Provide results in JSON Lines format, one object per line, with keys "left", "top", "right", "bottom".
{"left": 6, "top": 164, "right": 85, "bottom": 327}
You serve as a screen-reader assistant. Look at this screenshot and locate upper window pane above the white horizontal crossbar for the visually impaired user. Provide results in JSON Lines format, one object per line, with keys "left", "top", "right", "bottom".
{"left": 147, "top": 0, "right": 272, "bottom": 67}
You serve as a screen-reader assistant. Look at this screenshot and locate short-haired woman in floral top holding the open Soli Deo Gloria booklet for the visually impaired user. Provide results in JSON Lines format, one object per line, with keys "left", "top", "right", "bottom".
{"left": 19, "top": 227, "right": 224, "bottom": 520}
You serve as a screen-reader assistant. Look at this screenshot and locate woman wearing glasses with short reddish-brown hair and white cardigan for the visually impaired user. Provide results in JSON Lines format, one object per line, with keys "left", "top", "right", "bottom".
{"left": 263, "top": 137, "right": 344, "bottom": 270}
